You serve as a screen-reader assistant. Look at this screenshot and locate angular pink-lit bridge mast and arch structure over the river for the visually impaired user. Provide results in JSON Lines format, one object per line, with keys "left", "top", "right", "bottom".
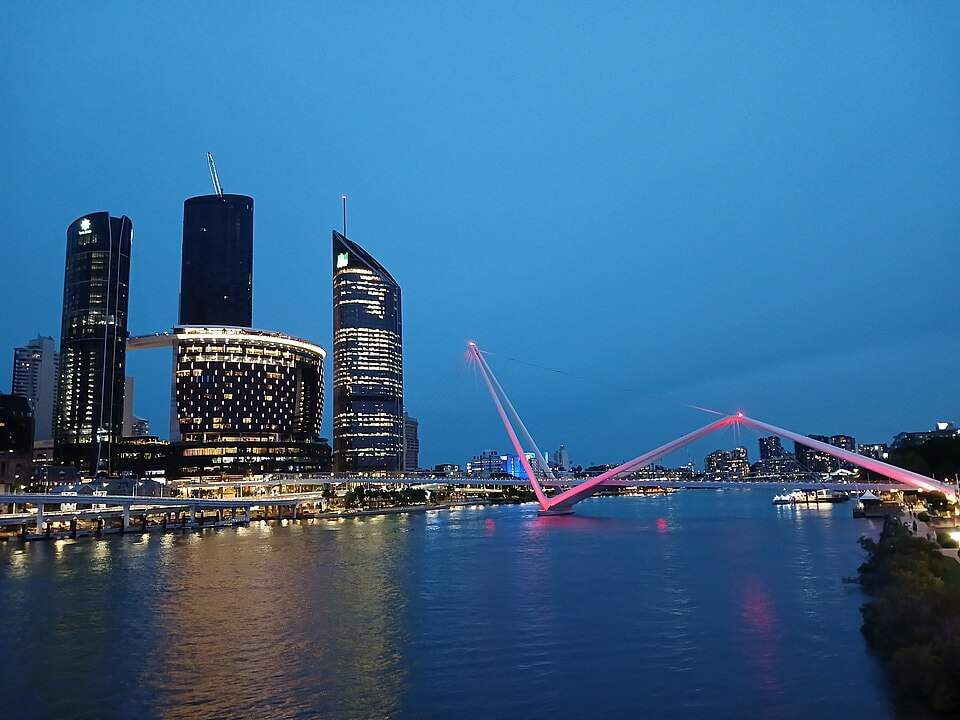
{"left": 467, "top": 341, "right": 956, "bottom": 515}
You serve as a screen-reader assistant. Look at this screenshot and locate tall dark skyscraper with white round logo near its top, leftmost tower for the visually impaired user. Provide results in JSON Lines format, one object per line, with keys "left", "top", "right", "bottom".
{"left": 53, "top": 212, "right": 133, "bottom": 474}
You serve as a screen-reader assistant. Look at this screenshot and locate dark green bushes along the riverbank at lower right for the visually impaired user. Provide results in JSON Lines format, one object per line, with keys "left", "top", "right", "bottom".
{"left": 859, "top": 519, "right": 960, "bottom": 718}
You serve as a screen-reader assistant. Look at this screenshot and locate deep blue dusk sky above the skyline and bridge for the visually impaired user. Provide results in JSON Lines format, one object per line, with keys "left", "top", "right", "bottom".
{"left": 0, "top": 2, "right": 960, "bottom": 466}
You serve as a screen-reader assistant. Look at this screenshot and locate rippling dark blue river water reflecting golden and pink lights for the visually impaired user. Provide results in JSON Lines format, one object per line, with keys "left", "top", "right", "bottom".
{"left": 0, "top": 490, "right": 895, "bottom": 720}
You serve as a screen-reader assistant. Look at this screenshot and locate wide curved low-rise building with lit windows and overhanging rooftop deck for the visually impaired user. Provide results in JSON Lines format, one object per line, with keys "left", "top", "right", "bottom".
{"left": 124, "top": 325, "right": 332, "bottom": 481}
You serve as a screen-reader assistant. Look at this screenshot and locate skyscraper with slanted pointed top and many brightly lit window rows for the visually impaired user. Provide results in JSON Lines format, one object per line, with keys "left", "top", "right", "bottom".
{"left": 333, "top": 230, "right": 404, "bottom": 472}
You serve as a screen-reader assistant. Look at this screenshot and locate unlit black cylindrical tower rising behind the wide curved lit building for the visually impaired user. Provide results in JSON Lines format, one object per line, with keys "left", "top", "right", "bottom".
{"left": 180, "top": 195, "right": 253, "bottom": 327}
